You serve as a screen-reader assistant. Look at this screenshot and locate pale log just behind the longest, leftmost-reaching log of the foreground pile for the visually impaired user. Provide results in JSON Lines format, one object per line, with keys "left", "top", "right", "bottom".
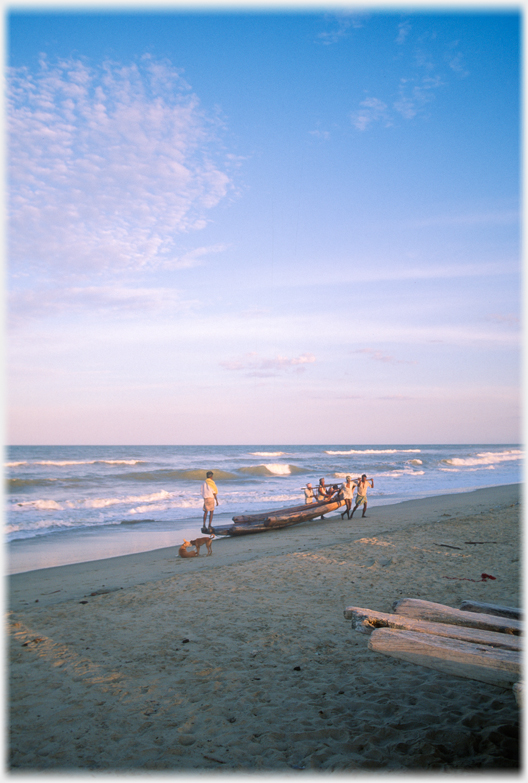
{"left": 392, "top": 598, "right": 522, "bottom": 635}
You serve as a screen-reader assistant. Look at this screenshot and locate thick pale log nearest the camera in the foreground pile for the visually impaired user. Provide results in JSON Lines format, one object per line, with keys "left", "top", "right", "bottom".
{"left": 369, "top": 628, "right": 521, "bottom": 686}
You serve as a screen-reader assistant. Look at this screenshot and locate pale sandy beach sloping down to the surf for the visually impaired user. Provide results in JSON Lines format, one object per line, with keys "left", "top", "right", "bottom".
{"left": 6, "top": 485, "right": 522, "bottom": 774}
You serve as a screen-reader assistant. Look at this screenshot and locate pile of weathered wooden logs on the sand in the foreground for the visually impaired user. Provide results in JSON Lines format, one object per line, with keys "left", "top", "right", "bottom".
{"left": 344, "top": 598, "right": 523, "bottom": 705}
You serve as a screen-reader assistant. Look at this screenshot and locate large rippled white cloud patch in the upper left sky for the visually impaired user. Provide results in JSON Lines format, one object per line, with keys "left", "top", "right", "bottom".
{"left": 8, "top": 56, "right": 232, "bottom": 275}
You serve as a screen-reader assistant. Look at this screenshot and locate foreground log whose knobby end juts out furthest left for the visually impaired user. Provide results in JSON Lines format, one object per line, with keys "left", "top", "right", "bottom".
{"left": 344, "top": 606, "right": 521, "bottom": 650}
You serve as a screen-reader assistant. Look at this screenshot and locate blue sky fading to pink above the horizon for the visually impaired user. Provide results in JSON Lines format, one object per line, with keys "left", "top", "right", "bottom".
{"left": 5, "top": 5, "right": 521, "bottom": 445}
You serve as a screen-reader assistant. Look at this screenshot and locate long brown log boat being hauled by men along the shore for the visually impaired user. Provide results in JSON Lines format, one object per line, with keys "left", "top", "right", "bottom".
{"left": 212, "top": 499, "right": 345, "bottom": 536}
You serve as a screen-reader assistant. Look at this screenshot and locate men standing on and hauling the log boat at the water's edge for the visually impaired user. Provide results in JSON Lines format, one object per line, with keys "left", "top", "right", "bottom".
{"left": 201, "top": 470, "right": 374, "bottom": 533}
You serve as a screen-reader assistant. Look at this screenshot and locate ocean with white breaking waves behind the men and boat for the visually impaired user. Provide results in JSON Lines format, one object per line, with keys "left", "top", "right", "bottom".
{"left": 5, "top": 444, "right": 523, "bottom": 573}
